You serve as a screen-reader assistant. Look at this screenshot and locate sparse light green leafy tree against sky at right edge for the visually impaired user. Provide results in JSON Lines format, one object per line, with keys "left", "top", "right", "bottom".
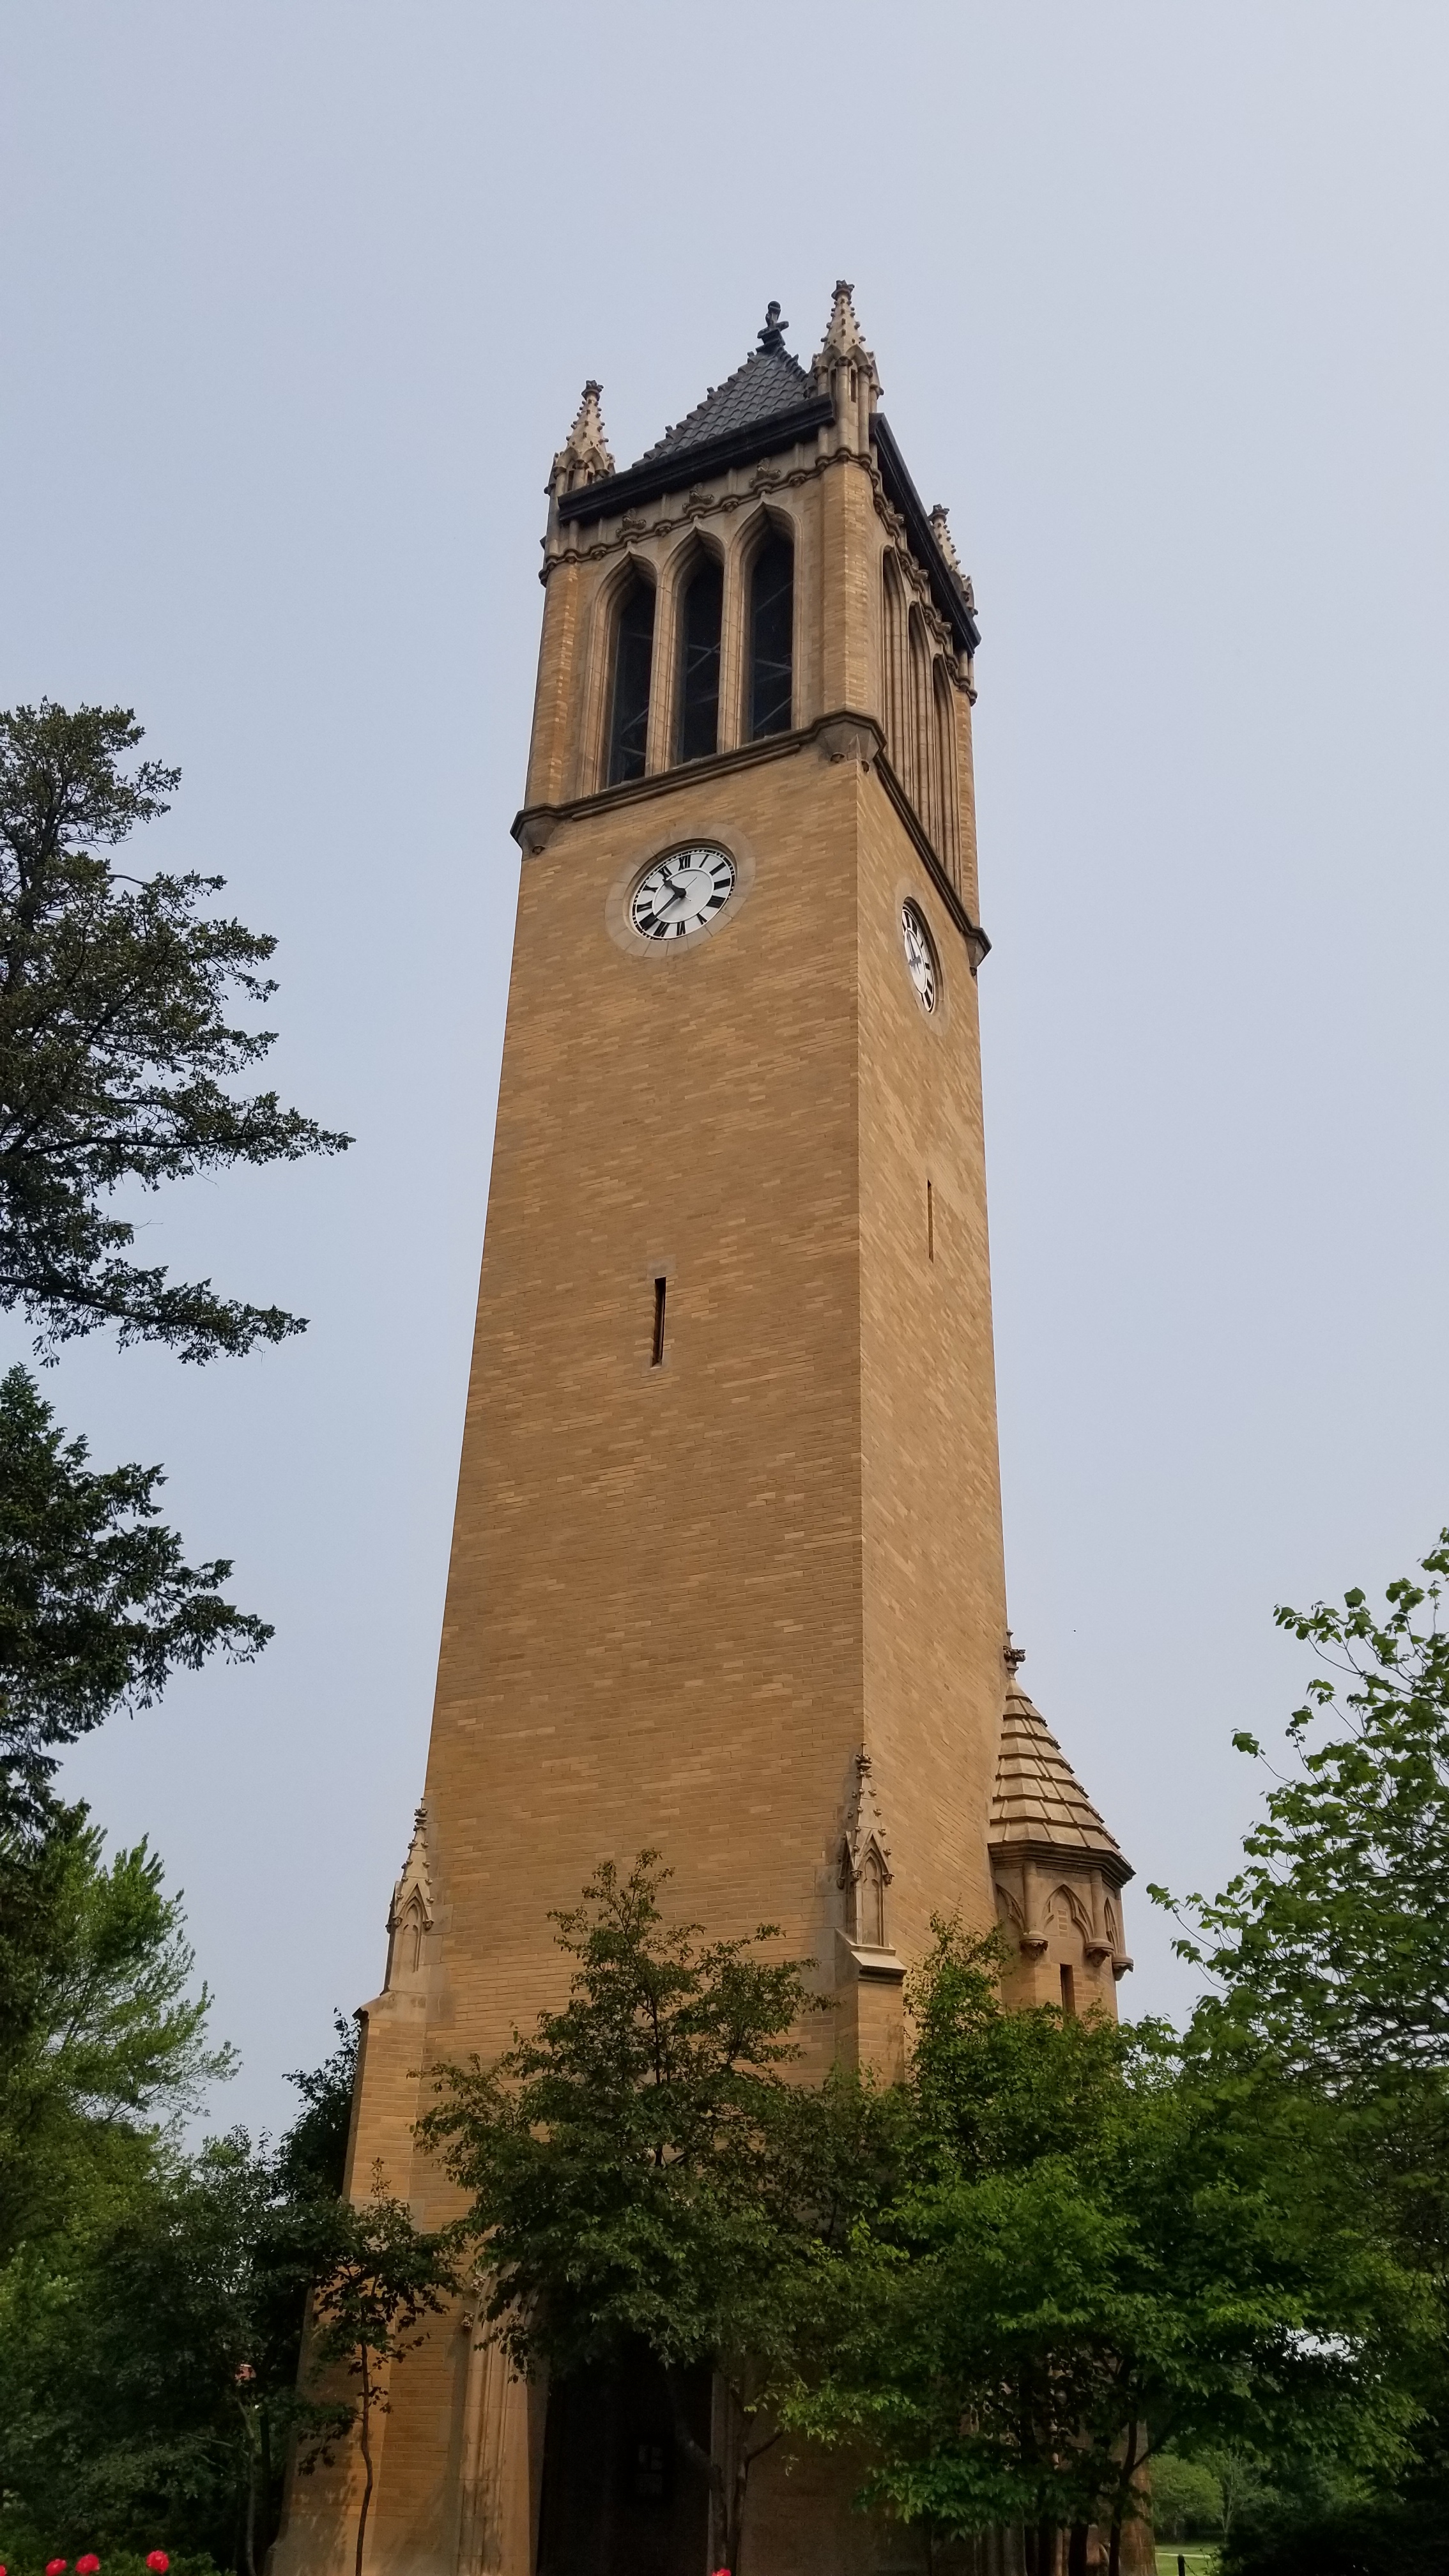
{"left": 1150, "top": 1533, "right": 1449, "bottom": 2571}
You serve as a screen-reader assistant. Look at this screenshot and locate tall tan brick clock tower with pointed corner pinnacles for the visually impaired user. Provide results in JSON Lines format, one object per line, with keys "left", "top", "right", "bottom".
{"left": 279, "top": 286, "right": 1127, "bottom": 2576}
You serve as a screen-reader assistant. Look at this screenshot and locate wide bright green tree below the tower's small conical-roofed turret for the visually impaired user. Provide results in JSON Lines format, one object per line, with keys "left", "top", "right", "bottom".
{"left": 789, "top": 1924, "right": 1426, "bottom": 2576}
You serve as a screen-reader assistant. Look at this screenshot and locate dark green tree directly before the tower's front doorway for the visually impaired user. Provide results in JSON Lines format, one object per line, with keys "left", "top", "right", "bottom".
{"left": 410, "top": 1852, "right": 889, "bottom": 2576}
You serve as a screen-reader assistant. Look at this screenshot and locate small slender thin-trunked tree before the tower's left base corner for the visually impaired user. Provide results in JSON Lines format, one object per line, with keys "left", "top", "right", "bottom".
{"left": 304, "top": 2161, "right": 461, "bottom": 2576}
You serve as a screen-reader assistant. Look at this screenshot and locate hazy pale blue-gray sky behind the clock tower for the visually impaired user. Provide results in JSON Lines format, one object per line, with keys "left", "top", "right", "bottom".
{"left": 0, "top": 0, "right": 1449, "bottom": 2120}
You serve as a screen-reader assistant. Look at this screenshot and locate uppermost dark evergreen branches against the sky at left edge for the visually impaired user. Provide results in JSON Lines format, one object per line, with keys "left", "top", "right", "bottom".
{"left": 0, "top": 701, "right": 348, "bottom": 1360}
